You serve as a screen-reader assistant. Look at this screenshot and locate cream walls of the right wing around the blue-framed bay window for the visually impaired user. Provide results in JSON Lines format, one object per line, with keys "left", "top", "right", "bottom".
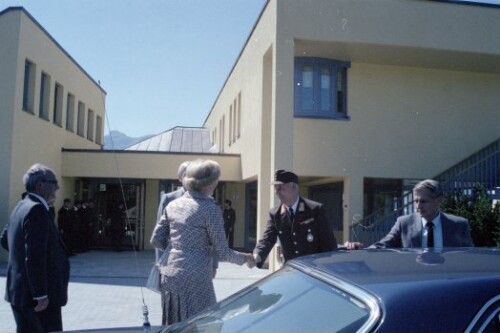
{"left": 205, "top": 0, "right": 500, "bottom": 268}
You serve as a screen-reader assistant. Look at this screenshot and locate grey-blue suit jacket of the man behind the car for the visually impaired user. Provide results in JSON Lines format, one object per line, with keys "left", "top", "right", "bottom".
{"left": 372, "top": 213, "right": 474, "bottom": 248}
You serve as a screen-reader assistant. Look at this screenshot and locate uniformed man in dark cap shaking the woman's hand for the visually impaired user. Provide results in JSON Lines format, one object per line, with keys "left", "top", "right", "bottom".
{"left": 253, "top": 170, "right": 337, "bottom": 268}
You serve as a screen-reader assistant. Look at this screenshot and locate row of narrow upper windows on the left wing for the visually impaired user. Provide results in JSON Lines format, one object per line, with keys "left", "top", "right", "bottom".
{"left": 23, "top": 60, "right": 103, "bottom": 145}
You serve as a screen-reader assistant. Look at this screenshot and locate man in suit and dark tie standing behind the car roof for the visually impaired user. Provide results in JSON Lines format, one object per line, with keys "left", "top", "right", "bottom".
{"left": 344, "top": 179, "right": 474, "bottom": 250}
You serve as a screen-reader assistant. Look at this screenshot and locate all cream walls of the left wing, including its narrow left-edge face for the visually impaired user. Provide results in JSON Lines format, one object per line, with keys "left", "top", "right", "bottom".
{"left": 0, "top": 10, "right": 105, "bottom": 256}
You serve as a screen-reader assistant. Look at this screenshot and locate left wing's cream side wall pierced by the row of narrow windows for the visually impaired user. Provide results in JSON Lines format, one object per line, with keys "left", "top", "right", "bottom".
{"left": 10, "top": 12, "right": 105, "bottom": 213}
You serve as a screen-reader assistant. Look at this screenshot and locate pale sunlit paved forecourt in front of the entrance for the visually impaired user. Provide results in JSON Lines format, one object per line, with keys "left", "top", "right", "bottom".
{"left": 0, "top": 251, "right": 269, "bottom": 332}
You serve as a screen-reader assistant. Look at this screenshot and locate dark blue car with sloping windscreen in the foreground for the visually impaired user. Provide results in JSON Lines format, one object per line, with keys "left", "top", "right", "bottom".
{"left": 162, "top": 248, "right": 500, "bottom": 333}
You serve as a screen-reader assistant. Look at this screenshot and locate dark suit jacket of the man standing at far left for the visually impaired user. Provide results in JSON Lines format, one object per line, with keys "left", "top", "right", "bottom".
{"left": 5, "top": 194, "right": 69, "bottom": 307}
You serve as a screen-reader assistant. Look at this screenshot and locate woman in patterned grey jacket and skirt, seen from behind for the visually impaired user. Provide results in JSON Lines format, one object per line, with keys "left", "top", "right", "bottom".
{"left": 151, "top": 160, "right": 255, "bottom": 325}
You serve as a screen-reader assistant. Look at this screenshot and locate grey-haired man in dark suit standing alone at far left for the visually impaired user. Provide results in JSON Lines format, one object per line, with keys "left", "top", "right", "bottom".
{"left": 5, "top": 164, "right": 69, "bottom": 332}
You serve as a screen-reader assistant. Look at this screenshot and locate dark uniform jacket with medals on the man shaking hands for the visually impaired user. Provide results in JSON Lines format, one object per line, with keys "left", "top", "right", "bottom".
{"left": 253, "top": 197, "right": 337, "bottom": 268}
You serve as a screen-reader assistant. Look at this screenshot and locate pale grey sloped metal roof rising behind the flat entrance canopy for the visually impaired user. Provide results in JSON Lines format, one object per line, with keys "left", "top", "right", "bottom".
{"left": 125, "top": 127, "right": 213, "bottom": 153}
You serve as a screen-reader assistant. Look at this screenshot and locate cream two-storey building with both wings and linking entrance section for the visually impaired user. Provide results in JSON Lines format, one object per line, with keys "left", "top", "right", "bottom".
{"left": 0, "top": 0, "right": 500, "bottom": 268}
